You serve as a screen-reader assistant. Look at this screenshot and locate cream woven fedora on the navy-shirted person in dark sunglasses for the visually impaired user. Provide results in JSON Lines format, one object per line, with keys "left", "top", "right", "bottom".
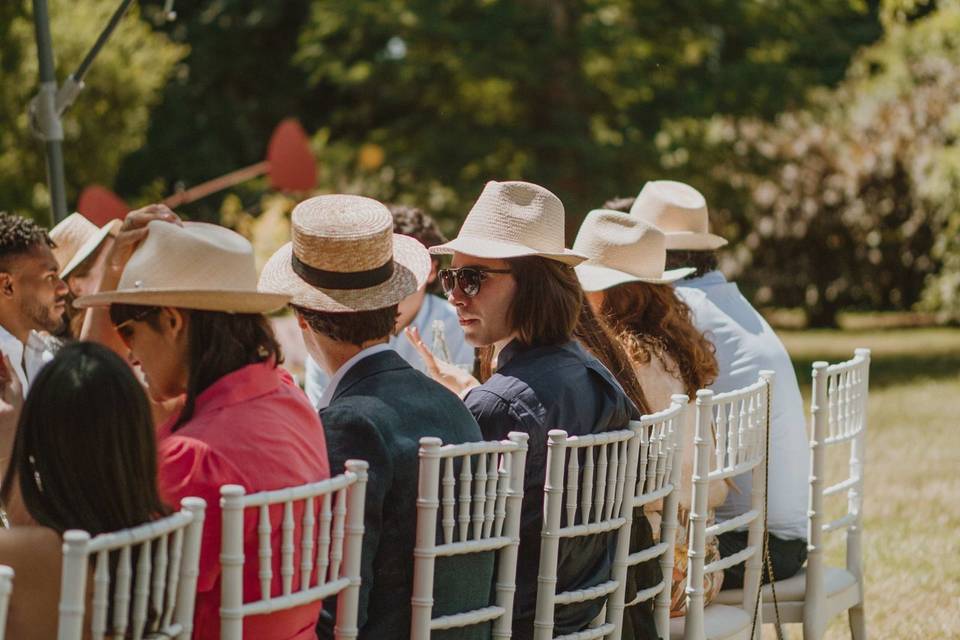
{"left": 430, "top": 180, "right": 586, "bottom": 265}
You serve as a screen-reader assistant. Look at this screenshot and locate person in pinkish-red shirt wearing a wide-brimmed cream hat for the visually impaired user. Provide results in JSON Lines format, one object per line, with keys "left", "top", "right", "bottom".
{"left": 76, "top": 206, "right": 330, "bottom": 640}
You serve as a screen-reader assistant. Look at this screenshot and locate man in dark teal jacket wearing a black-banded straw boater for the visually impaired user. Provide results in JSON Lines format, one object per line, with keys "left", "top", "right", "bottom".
{"left": 260, "top": 195, "right": 493, "bottom": 640}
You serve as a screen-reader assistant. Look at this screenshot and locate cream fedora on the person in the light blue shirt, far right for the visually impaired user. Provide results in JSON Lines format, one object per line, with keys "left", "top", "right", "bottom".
{"left": 630, "top": 180, "right": 727, "bottom": 251}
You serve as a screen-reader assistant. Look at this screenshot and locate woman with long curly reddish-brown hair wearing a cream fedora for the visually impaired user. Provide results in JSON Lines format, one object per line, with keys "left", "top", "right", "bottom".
{"left": 574, "top": 209, "right": 727, "bottom": 615}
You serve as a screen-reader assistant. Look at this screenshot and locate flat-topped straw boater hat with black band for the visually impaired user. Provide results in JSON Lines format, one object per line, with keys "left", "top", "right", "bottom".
{"left": 260, "top": 194, "right": 431, "bottom": 313}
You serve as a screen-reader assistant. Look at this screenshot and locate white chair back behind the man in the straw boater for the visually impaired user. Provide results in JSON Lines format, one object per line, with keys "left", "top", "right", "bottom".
{"left": 410, "top": 432, "right": 528, "bottom": 640}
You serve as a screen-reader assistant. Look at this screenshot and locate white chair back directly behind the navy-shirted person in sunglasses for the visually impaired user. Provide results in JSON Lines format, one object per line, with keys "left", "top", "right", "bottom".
{"left": 534, "top": 421, "right": 640, "bottom": 640}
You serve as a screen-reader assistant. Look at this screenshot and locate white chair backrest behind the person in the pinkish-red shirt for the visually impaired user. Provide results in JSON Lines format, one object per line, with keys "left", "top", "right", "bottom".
{"left": 220, "top": 460, "right": 367, "bottom": 640}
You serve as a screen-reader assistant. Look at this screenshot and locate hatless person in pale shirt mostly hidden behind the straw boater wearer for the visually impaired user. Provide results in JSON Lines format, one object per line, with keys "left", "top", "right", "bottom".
{"left": 304, "top": 204, "right": 474, "bottom": 408}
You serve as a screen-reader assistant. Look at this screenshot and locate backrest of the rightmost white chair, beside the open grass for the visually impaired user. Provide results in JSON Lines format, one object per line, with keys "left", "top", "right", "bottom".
{"left": 807, "top": 349, "right": 870, "bottom": 599}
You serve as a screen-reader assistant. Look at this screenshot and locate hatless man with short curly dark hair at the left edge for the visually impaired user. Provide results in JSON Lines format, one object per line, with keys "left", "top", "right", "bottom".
{"left": 0, "top": 213, "right": 68, "bottom": 393}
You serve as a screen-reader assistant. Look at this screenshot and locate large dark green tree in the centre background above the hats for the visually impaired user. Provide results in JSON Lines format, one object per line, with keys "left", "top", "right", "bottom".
{"left": 297, "top": 0, "right": 880, "bottom": 223}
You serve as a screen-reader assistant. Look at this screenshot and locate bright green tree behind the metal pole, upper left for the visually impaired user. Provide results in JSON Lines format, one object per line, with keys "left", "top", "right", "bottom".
{"left": 0, "top": 0, "right": 185, "bottom": 220}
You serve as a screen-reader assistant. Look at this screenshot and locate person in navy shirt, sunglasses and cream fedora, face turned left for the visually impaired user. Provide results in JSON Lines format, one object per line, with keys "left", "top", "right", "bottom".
{"left": 418, "top": 181, "right": 638, "bottom": 638}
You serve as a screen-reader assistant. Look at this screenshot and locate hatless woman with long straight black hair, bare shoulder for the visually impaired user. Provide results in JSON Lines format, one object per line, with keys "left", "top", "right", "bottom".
{"left": 0, "top": 343, "right": 167, "bottom": 638}
